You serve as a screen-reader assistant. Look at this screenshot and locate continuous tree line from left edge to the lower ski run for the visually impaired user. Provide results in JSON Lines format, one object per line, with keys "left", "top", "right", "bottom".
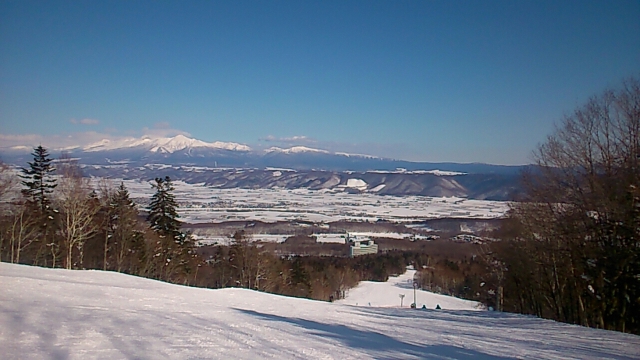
{"left": 0, "top": 154, "right": 440, "bottom": 301}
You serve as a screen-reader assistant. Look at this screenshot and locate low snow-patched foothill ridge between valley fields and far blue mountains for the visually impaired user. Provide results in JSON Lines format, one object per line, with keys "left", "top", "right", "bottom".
{"left": 76, "top": 164, "right": 520, "bottom": 200}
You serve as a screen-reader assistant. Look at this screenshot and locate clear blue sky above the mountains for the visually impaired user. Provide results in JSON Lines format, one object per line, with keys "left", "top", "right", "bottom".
{"left": 0, "top": 0, "right": 640, "bottom": 164}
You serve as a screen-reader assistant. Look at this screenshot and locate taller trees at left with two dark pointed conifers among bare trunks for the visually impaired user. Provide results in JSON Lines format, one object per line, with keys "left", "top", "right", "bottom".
{"left": 0, "top": 146, "right": 197, "bottom": 283}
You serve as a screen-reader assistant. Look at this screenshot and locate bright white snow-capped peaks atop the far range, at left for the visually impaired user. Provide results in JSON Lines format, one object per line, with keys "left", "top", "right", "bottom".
{"left": 82, "top": 135, "right": 251, "bottom": 154}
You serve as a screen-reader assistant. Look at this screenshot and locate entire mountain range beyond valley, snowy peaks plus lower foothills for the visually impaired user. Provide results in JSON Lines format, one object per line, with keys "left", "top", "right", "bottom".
{"left": 0, "top": 135, "right": 527, "bottom": 200}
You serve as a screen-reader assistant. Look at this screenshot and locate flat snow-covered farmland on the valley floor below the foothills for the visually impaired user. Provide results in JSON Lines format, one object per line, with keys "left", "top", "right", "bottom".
{"left": 104, "top": 179, "right": 508, "bottom": 224}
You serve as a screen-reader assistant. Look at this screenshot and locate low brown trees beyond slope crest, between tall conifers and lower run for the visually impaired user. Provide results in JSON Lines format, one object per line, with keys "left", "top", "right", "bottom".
{"left": 198, "top": 238, "right": 426, "bottom": 301}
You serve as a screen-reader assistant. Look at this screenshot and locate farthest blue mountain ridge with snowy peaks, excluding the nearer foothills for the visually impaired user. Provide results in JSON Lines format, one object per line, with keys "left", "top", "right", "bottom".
{"left": 0, "top": 135, "right": 523, "bottom": 174}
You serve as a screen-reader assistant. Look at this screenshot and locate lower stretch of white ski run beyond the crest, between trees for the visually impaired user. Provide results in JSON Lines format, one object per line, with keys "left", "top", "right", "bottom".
{"left": 337, "top": 270, "right": 484, "bottom": 310}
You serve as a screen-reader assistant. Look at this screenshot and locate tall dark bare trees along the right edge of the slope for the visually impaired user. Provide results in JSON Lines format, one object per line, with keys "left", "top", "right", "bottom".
{"left": 492, "top": 79, "right": 640, "bottom": 334}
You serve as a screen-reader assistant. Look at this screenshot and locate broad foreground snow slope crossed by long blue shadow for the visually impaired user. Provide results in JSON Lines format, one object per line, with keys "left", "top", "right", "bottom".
{"left": 0, "top": 263, "right": 640, "bottom": 359}
